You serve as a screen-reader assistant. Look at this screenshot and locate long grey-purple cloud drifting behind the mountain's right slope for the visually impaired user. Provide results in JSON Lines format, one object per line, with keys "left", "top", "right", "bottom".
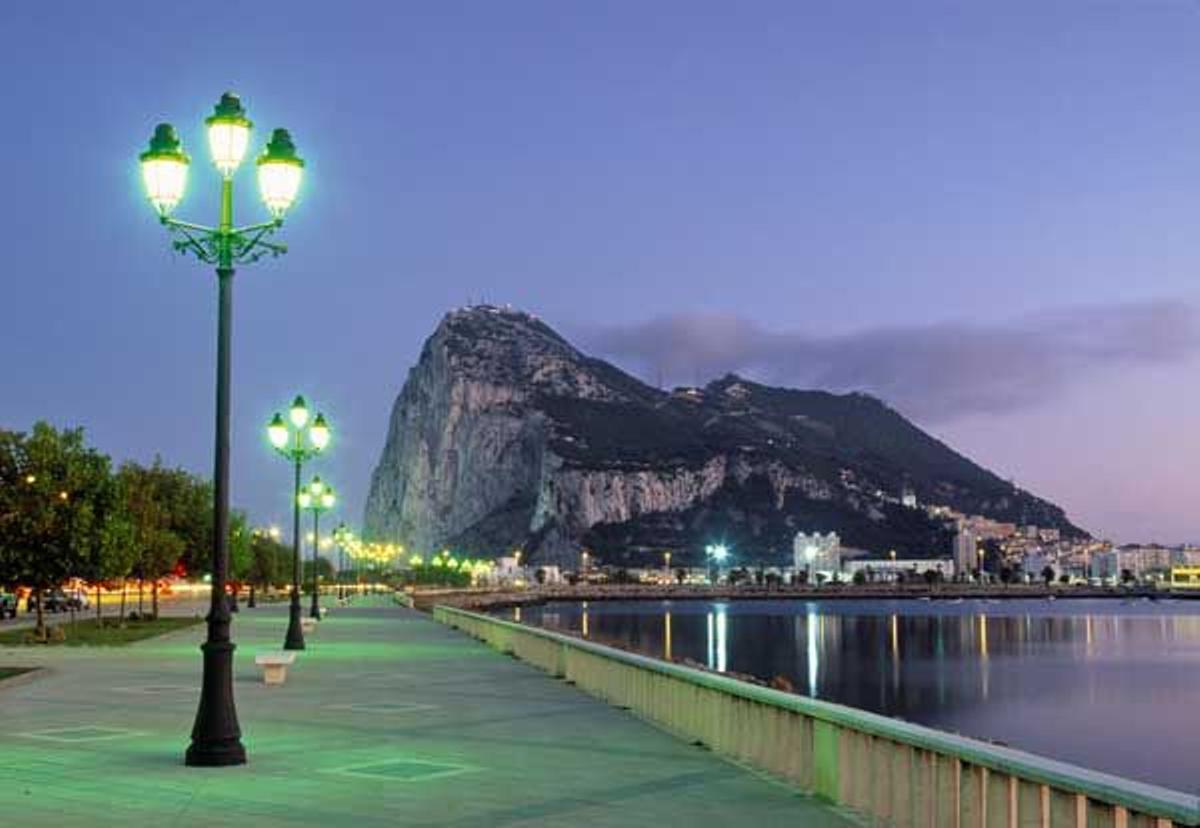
{"left": 582, "top": 301, "right": 1200, "bottom": 422}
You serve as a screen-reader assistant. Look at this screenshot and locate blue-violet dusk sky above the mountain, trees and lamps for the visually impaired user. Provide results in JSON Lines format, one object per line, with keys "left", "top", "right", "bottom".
{"left": 0, "top": 0, "right": 1200, "bottom": 542}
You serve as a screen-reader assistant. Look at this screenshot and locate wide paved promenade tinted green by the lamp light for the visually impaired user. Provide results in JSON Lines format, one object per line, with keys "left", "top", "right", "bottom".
{"left": 0, "top": 599, "right": 853, "bottom": 828}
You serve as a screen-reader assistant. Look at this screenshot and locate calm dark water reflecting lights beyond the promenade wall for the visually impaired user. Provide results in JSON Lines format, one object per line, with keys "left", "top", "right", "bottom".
{"left": 503, "top": 600, "right": 1200, "bottom": 792}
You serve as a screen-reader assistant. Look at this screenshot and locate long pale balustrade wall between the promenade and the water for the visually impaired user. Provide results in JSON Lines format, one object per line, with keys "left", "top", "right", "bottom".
{"left": 433, "top": 606, "right": 1200, "bottom": 828}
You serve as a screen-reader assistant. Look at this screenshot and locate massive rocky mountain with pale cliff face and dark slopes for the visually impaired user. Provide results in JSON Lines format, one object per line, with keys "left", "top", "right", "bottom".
{"left": 365, "top": 306, "right": 1079, "bottom": 565}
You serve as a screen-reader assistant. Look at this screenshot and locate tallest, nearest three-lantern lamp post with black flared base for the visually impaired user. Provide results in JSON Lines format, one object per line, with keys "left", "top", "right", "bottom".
{"left": 139, "top": 92, "right": 304, "bottom": 767}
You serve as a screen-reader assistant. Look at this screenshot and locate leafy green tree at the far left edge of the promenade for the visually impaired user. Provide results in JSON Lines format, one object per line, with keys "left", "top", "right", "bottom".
{"left": 0, "top": 422, "right": 114, "bottom": 641}
